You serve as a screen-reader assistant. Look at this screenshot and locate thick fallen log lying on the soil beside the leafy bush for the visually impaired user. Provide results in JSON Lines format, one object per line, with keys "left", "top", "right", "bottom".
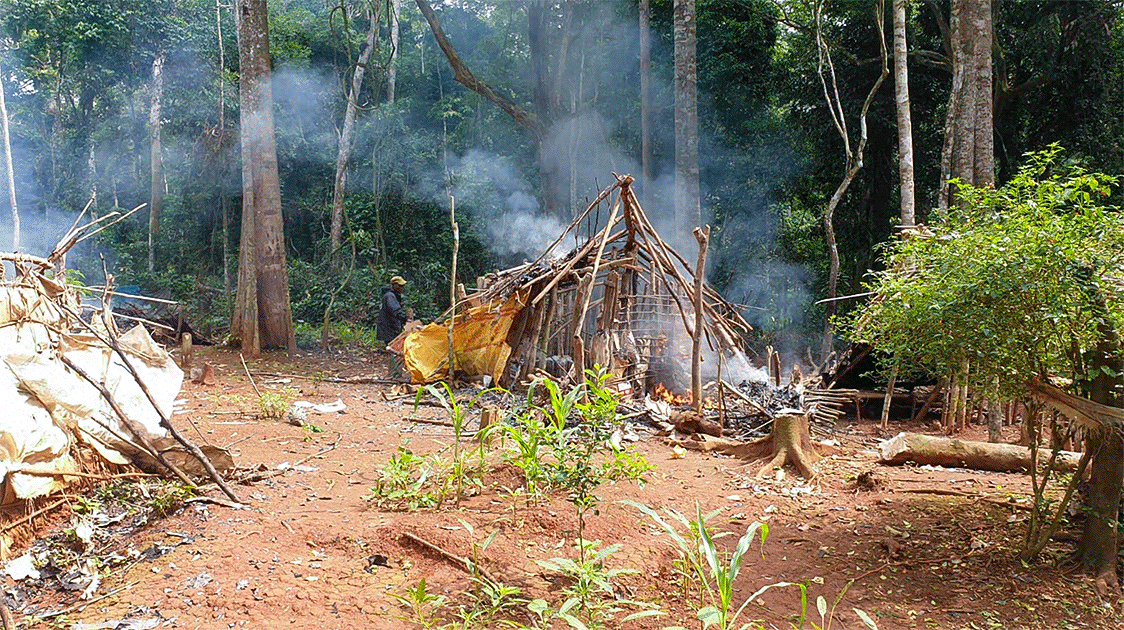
{"left": 878, "top": 433, "right": 1081, "bottom": 473}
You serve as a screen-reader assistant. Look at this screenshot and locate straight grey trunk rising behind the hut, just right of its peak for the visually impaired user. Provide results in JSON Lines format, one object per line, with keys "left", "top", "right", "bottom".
{"left": 673, "top": 0, "right": 703, "bottom": 231}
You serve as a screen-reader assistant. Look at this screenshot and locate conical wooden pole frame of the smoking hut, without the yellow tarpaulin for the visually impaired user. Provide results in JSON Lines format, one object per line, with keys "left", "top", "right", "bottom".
{"left": 454, "top": 174, "right": 752, "bottom": 390}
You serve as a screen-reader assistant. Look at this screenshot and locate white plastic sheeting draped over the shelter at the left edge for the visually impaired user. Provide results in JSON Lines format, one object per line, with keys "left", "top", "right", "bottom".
{"left": 0, "top": 287, "right": 183, "bottom": 505}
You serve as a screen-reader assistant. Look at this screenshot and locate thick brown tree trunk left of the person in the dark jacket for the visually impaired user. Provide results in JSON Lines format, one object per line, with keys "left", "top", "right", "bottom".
{"left": 232, "top": 0, "right": 297, "bottom": 351}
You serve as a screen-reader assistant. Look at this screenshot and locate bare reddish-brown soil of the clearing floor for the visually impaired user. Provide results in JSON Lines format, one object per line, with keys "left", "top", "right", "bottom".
{"left": 4, "top": 348, "right": 1122, "bottom": 630}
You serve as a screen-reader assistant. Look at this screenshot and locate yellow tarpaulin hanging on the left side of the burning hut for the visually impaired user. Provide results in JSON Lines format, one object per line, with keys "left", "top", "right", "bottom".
{"left": 404, "top": 293, "right": 527, "bottom": 383}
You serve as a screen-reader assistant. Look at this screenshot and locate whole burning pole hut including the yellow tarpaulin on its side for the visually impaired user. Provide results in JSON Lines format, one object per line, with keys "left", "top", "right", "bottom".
{"left": 404, "top": 176, "right": 751, "bottom": 393}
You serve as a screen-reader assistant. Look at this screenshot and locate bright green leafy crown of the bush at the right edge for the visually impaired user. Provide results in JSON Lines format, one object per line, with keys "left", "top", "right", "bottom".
{"left": 847, "top": 147, "right": 1124, "bottom": 399}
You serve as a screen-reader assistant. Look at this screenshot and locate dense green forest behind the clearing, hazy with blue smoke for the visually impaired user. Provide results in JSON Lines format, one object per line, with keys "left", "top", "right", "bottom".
{"left": 0, "top": 0, "right": 1124, "bottom": 357}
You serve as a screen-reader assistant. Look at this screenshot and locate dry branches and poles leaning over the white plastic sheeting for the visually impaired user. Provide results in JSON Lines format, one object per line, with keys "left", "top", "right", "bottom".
{"left": 0, "top": 200, "right": 238, "bottom": 502}
